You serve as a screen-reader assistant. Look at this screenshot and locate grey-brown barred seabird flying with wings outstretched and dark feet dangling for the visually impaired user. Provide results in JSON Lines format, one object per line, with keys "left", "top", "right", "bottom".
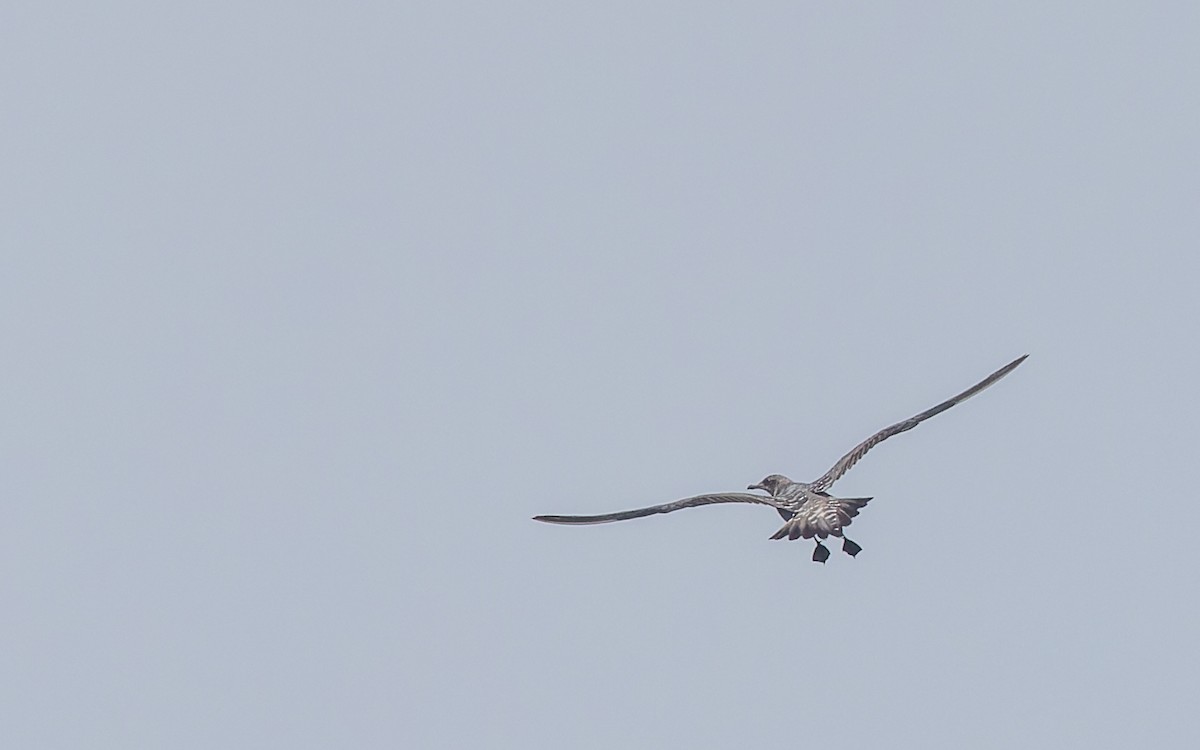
{"left": 533, "top": 354, "right": 1028, "bottom": 563}
